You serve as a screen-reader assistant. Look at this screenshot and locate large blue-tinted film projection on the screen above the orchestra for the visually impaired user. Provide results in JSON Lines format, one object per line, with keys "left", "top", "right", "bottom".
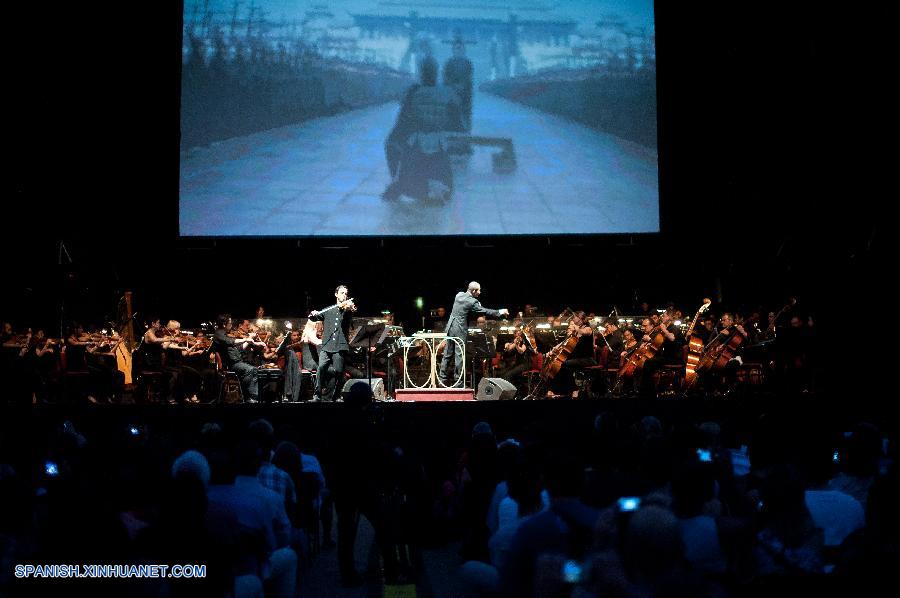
{"left": 179, "top": 0, "right": 659, "bottom": 237}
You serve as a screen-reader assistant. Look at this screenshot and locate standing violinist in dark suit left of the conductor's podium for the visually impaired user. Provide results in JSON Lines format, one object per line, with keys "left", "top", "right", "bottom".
{"left": 309, "top": 285, "right": 356, "bottom": 401}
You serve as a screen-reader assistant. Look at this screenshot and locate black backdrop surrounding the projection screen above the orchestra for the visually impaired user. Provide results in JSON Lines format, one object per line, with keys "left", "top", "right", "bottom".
{"left": 0, "top": 2, "right": 894, "bottom": 398}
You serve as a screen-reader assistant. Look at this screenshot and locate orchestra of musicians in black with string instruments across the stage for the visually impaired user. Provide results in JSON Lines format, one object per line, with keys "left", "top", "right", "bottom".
{"left": 2, "top": 288, "right": 813, "bottom": 405}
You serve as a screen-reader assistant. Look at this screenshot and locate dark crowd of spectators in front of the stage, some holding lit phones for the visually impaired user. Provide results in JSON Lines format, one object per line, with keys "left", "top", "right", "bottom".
{"left": 0, "top": 406, "right": 900, "bottom": 596}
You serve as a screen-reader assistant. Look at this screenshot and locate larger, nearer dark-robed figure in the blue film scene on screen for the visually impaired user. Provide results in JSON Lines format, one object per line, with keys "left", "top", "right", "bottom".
{"left": 382, "top": 56, "right": 465, "bottom": 202}
